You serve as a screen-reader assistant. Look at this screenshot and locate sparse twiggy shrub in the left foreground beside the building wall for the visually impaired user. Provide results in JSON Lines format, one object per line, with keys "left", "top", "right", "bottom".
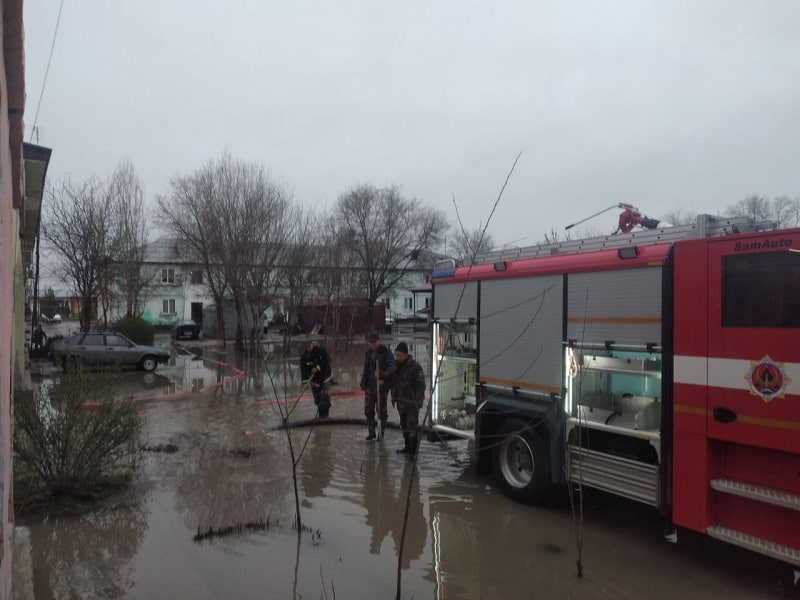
{"left": 14, "top": 369, "right": 142, "bottom": 506}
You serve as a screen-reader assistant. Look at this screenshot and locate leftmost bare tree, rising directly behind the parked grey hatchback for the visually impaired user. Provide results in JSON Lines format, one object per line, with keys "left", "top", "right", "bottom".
{"left": 42, "top": 178, "right": 114, "bottom": 331}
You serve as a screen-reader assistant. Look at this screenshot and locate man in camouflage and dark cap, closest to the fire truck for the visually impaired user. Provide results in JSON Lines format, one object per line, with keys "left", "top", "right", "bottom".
{"left": 382, "top": 342, "right": 425, "bottom": 460}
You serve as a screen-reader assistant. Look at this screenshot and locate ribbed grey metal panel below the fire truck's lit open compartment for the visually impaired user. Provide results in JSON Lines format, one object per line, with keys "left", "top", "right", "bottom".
{"left": 569, "top": 445, "right": 661, "bottom": 508}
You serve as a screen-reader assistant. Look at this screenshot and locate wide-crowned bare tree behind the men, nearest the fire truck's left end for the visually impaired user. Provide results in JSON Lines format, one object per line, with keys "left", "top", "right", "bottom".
{"left": 334, "top": 184, "right": 448, "bottom": 323}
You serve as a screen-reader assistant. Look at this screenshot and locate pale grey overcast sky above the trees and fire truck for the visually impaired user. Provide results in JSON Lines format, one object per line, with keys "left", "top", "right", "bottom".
{"left": 25, "top": 0, "right": 800, "bottom": 245}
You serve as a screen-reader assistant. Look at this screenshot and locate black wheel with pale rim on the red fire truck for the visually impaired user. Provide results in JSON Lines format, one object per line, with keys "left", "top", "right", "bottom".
{"left": 494, "top": 419, "right": 550, "bottom": 503}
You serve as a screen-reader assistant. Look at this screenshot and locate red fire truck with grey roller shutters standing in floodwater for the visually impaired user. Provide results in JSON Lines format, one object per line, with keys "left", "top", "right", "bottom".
{"left": 431, "top": 215, "right": 800, "bottom": 565}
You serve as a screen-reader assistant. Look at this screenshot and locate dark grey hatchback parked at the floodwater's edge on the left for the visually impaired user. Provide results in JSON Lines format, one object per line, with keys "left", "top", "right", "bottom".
{"left": 51, "top": 331, "right": 170, "bottom": 371}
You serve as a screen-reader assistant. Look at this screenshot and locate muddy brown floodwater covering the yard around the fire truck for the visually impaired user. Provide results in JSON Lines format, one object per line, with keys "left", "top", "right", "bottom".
{"left": 14, "top": 341, "right": 800, "bottom": 600}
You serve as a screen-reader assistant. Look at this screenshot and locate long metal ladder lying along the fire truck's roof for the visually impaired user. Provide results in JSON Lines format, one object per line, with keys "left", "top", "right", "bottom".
{"left": 473, "top": 215, "right": 775, "bottom": 264}
